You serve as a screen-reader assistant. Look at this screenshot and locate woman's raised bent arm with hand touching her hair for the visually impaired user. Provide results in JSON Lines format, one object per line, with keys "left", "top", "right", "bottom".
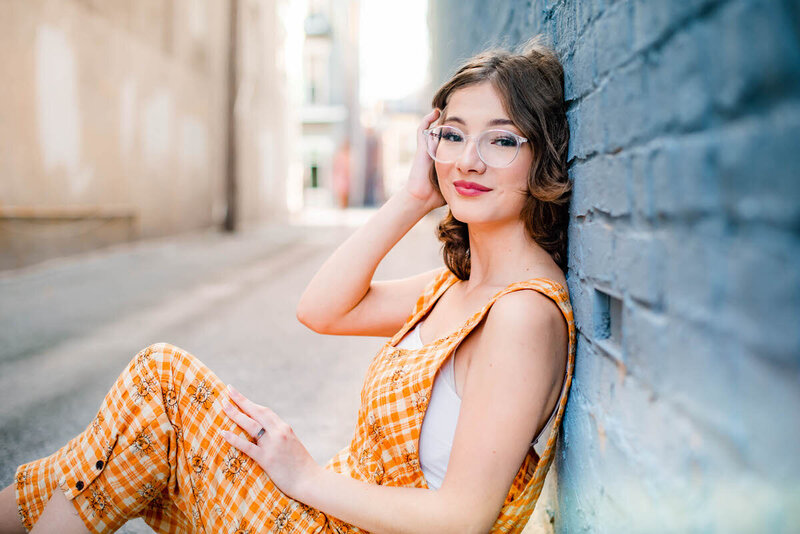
{"left": 297, "top": 111, "right": 444, "bottom": 336}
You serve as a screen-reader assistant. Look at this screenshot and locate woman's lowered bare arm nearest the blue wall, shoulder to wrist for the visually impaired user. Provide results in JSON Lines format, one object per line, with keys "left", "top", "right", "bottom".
{"left": 295, "top": 291, "right": 568, "bottom": 533}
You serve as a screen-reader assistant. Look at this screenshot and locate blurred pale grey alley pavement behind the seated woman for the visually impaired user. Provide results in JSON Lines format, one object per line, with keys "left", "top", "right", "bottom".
{"left": 0, "top": 210, "right": 442, "bottom": 533}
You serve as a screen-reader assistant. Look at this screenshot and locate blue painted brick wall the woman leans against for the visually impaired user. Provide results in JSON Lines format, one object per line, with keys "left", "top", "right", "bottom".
{"left": 429, "top": 0, "right": 800, "bottom": 533}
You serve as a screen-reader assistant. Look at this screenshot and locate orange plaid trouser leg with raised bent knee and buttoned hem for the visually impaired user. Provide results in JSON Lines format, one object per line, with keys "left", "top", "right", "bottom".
{"left": 16, "top": 343, "right": 334, "bottom": 533}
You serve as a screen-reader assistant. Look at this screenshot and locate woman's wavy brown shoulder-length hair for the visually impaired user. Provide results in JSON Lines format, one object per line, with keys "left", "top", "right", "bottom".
{"left": 430, "top": 34, "right": 572, "bottom": 280}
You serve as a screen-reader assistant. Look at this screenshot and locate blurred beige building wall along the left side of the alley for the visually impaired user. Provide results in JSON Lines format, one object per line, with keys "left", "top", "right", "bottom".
{"left": 0, "top": 0, "right": 302, "bottom": 269}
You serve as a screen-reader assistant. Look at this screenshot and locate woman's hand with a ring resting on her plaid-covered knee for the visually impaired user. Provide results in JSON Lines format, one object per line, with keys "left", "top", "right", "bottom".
{"left": 222, "top": 385, "right": 321, "bottom": 499}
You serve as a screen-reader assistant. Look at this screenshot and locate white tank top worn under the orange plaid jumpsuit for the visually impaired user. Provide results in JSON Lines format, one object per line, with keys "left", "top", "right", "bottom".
{"left": 397, "top": 321, "right": 567, "bottom": 489}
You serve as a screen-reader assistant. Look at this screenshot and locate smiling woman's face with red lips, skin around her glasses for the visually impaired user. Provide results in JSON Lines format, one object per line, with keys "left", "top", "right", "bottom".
{"left": 434, "top": 82, "right": 533, "bottom": 226}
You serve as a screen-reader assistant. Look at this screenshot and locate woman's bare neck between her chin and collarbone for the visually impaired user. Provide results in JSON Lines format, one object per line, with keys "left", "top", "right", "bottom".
{"left": 465, "top": 221, "right": 553, "bottom": 292}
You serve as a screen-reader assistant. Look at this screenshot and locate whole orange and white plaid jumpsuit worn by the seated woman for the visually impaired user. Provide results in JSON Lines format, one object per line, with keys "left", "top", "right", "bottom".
{"left": 15, "top": 268, "right": 575, "bottom": 534}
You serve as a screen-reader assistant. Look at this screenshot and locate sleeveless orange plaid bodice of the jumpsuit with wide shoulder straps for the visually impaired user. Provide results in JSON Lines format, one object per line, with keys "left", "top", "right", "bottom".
{"left": 325, "top": 267, "right": 575, "bottom": 532}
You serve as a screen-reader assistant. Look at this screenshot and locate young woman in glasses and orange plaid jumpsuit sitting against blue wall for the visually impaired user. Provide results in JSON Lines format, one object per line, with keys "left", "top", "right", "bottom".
{"left": 0, "top": 35, "right": 575, "bottom": 533}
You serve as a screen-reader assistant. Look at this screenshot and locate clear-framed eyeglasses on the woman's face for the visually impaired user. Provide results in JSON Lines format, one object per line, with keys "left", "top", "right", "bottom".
{"left": 423, "top": 126, "right": 528, "bottom": 167}
